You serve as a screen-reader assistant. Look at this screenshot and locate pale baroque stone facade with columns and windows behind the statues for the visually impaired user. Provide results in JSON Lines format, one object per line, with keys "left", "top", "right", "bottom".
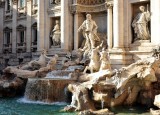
{"left": 0, "top": 0, "right": 160, "bottom": 68}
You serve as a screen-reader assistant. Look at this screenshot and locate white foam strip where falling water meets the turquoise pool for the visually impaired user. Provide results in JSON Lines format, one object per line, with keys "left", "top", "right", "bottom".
{"left": 17, "top": 98, "right": 67, "bottom": 105}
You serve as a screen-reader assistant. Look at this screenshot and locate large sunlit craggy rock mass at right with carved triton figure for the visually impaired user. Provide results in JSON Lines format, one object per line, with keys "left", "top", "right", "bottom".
{"left": 65, "top": 57, "right": 160, "bottom": 111}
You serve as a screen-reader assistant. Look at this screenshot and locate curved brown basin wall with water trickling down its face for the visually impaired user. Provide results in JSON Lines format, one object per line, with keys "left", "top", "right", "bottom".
{"left": 25, "top": 78, "right": 75, "bottom": 103}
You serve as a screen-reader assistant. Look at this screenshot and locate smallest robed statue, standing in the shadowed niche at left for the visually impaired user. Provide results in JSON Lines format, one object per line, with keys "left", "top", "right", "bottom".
{"left": 50, "top": 20, "right": 61, "bottom": 46}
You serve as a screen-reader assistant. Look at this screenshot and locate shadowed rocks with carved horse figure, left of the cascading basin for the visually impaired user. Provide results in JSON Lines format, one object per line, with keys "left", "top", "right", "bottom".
{"left": 0, "top": 50, "right": 58, "bottom": 96}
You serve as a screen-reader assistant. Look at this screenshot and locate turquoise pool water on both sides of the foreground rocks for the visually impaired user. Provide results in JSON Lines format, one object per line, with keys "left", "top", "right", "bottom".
{"left": 0, "top": 98, "right": 150, "bottom": 115}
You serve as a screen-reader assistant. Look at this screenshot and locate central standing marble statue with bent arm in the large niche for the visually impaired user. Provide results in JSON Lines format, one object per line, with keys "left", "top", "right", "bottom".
{"left": 78, "top": 14, "right": 100, "bottom": 51}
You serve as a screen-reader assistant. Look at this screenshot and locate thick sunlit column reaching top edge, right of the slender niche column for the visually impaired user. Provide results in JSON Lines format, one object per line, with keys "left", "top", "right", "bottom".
{"left": 113, "top": 0, "right": 124, "bottom": 49}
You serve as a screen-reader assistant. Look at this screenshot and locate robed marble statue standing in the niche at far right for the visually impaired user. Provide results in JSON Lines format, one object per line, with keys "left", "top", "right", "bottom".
{"left": 132, "top": 5, "right": 151, "bottom": 41}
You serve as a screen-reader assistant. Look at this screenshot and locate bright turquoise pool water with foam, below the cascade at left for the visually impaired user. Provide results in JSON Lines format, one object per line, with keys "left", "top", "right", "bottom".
{"left": 0, "top": 98, "right": 76, "bottom": 115}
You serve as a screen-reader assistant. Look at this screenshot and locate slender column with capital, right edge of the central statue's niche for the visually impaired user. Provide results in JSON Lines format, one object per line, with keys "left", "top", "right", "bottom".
{"left": 107, "top": 5, "right": 113, "bottom": 49}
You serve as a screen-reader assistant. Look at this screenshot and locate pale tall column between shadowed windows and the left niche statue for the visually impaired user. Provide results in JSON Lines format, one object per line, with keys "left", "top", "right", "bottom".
{"left": 37, "top": 0, "right": 44, "bottom": 51}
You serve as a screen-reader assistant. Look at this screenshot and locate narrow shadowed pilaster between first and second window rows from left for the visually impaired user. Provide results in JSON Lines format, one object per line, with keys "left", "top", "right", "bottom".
{"left": 12, "top": 1, "right": 17, "bottom": 53}
